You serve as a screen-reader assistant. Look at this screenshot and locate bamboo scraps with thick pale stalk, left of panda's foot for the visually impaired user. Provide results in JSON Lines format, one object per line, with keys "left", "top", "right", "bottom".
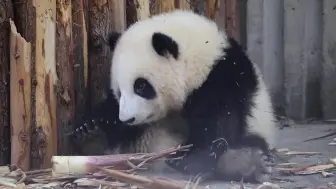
{"left": 0, "top": 145, "right": 200, "bottom": 189}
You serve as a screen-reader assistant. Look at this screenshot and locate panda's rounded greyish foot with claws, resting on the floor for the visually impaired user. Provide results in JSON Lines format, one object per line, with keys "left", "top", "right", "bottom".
{"left": 216, "top": 148, "right": 272, "bottom": 183}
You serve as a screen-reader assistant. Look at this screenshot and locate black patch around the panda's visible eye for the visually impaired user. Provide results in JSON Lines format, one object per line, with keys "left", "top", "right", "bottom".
{"left": 133, "top": 77, "right": 156, "bottom": 100}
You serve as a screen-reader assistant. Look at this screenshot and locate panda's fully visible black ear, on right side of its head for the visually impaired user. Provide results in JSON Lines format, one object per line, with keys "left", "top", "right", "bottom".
{"left": 152, "top": 32, "right": 179, "bottom": 59}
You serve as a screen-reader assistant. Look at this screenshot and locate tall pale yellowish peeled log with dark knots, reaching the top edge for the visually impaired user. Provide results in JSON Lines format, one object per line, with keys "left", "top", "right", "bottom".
{"left": 32, "top": 0, "right": 57, "bottom": 168}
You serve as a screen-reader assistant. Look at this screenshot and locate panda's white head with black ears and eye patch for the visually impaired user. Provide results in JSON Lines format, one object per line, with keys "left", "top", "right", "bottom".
{"left": 110, "top": 11, "right": 226, "bottom": 125}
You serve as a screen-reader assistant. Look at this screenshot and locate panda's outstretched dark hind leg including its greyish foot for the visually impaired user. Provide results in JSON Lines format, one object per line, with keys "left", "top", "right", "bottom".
{"left": 167, "top": 137, "right": 272, "bottom": 183}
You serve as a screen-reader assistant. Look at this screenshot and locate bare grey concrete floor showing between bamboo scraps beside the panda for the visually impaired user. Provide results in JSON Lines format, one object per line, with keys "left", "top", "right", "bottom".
{"left": 146, "top": 124, "right": 336, "bottom": 189}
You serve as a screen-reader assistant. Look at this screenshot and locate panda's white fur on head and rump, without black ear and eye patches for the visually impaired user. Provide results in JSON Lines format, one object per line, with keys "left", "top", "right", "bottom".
{"left": 111, "top": 11, "right": 276, "bottom": 148}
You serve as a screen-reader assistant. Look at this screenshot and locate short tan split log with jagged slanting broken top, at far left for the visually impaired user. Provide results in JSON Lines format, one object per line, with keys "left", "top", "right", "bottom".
{"left": 10, "top": 20, "right": 31, "bottom": 170}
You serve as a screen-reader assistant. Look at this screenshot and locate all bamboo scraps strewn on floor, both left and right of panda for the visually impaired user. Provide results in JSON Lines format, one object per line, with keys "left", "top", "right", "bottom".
{"left": 0, "top": 145, "right": 336, "bottom": 189}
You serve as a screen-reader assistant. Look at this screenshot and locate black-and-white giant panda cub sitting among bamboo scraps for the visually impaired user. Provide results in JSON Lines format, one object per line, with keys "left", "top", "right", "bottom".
{"left": 109, "top": 10, "right": 276, "bottom": 181}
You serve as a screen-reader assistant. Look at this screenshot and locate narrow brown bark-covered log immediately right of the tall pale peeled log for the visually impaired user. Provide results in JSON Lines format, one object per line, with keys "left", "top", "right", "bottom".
{"left": 56, "top": 0, "right": 75, "bottom": 155}
